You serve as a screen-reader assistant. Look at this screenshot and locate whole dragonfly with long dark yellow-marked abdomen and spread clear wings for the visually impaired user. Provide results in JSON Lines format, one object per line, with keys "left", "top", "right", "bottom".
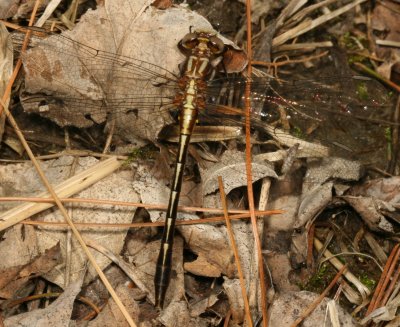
{"left": 13, "top": 26, "right": 394, "bottom": 308}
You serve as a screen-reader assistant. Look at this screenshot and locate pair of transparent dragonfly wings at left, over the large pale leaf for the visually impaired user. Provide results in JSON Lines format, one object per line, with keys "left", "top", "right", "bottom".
{"left": 13, "top": 33, "right": 177, "bottom": 140}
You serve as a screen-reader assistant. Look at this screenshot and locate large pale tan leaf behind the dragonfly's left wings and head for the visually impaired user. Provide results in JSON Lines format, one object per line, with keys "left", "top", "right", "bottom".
{"left": 18, "top": 0, "right": 217, "bottom": 145}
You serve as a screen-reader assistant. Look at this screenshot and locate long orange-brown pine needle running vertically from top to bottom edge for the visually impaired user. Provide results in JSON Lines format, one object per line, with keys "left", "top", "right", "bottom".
{"left": 245, "top": 0, "right": 268, "bottom": 327}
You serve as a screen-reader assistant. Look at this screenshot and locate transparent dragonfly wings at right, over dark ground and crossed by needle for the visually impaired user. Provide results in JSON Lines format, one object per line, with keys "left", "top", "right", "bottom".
{"left": 202, "top": 75, "right": 398, "bottom": 163}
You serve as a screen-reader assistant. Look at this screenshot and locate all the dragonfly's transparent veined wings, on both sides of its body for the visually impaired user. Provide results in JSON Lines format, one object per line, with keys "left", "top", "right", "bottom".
{"left": 14, "top": 29, "right": 394, "bottom": 167}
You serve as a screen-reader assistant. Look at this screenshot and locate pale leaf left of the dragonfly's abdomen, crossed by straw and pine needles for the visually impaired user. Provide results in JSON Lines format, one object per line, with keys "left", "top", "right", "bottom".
{"left": 0, "top": 157, "right": 138, "bottom": 287}
